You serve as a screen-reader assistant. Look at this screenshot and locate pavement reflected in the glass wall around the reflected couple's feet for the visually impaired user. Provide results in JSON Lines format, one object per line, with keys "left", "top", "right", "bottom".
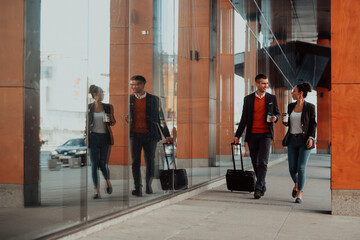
{"left": 0, "top": 152, "right": 286, "bottom": 239}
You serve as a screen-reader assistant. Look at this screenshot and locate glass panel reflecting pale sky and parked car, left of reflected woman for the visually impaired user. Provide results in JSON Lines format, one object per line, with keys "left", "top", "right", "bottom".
{"left": 39, "top": 0, "right": 89, "bottom": 233}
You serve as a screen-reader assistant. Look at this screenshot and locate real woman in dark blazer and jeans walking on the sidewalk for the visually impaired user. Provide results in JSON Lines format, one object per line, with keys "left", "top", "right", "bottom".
{"left": 283, "top": 83, "right": 316, "bottom": 203}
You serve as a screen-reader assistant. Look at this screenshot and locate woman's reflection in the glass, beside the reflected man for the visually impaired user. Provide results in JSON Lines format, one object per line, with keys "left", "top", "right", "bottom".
{"left": 88, "top": 85, "right": 115, "bottom": 199}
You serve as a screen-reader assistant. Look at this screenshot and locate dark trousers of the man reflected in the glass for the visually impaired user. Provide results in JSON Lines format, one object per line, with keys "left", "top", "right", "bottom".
{"left": 130, "top": 132, "right": 157, "bottom": 189}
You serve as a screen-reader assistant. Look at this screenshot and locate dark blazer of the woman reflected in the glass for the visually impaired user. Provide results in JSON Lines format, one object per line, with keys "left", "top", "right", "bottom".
{"left": 88, "top": 103, "right": 115, "bottom": 146}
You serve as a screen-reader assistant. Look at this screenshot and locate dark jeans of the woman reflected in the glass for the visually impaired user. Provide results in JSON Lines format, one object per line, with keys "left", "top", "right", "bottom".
{"left": 89, "top": 133, "right": 110, "bottom": 188}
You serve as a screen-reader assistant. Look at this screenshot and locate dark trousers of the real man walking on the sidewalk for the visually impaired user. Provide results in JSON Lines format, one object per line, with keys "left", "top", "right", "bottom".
{"left": 248, "top": 133, "right": 271, "bottom": 192}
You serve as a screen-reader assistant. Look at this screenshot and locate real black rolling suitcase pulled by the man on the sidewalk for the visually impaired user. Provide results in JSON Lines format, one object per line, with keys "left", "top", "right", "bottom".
{"left": 226, "top": 143, "right": 255, "bottom": 192}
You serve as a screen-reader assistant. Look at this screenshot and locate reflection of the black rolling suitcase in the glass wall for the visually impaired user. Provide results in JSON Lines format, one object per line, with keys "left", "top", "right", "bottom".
{"left": 160, "top": 143, "right": 188, "bottom": 190}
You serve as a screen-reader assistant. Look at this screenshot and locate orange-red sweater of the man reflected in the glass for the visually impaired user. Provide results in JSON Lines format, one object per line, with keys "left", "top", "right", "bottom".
{"left": 131, "top": 97, "right": 149, "bottom": 133}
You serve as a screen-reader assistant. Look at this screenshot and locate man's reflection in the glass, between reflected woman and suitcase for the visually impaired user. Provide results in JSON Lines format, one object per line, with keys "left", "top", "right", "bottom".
{"left": 126, "top": 75, "right": 171, "bottom": 197}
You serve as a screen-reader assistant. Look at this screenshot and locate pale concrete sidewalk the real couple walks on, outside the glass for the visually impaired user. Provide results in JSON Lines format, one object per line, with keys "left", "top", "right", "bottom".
{"left": 75, "top": 155, "right": 360, "bottom": 240}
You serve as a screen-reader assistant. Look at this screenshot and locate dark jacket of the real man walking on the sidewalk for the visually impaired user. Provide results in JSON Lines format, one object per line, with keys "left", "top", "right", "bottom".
{"left": 235, "top": 93, "right": 280, "bottom": 142}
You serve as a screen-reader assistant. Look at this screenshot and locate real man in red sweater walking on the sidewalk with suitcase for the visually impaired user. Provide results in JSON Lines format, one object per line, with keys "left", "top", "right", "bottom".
{"left": 234, "top": 74, "right": 280, "bottom": 199}
